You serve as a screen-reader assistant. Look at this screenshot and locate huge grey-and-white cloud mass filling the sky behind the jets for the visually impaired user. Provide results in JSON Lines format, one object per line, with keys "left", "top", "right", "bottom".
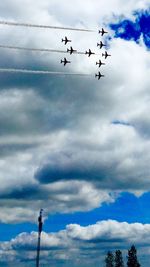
{"left": 0, "top": 0, "right": 150, "bottom": 222}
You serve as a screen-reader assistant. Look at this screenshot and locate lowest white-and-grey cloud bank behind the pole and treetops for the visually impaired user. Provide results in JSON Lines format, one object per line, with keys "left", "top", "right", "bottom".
{"left": 0, "top": 220, "right": 150, "bottom": 267}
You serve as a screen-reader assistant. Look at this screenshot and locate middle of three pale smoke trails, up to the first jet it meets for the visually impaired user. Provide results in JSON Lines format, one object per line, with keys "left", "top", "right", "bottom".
{"left": 0, "top": 45, "right": 68, "bottom": 53}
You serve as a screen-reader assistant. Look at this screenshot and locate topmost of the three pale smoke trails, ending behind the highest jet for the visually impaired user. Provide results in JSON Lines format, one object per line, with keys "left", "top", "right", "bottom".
{"left": 0, "top": 21, "right": 95, "bottom": 32}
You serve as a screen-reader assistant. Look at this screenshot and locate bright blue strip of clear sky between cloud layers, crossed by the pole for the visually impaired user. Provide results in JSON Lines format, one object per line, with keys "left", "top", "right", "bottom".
{"left": 0, "top": 193, "right": 150, "bottom": 241}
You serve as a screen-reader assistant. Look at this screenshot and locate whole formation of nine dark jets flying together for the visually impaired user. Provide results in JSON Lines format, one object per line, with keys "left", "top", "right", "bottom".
{"left": 60, "top": 28, "right": 111, "bottom": 80}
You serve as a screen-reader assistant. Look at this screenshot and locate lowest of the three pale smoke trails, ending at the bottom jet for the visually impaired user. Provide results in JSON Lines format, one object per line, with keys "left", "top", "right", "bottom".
{"left": 0, "top": 68, "right": 91, "bottom": 76}
